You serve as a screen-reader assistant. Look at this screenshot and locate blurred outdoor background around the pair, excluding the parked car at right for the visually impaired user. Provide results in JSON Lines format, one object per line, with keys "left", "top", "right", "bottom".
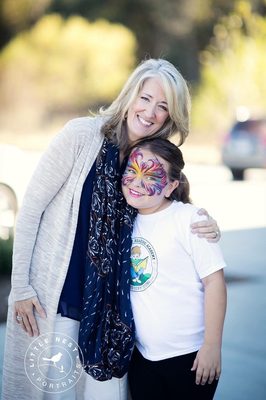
{"left": 0, "top": 0, "right": 266, "bottom": 400}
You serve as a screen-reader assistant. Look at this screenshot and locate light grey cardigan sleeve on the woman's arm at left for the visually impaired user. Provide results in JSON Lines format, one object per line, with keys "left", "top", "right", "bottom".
{"left": 12, "top": 125, "right": 76, "bottom": 301}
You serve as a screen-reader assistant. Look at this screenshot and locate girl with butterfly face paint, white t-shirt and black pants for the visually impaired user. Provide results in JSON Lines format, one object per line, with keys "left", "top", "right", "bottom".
{"left": 122, "top": 139, "right": 226, "bottom": 400}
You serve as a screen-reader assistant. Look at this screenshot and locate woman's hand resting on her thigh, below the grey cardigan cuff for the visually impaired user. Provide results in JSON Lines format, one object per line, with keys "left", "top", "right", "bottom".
{"left": 14, "top": 297, "right": 46, "bottom": 336}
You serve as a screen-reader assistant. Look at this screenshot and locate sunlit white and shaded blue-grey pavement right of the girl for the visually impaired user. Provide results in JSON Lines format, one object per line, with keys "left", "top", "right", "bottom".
{"left": 0, "top": 166, "right": 266, "bottom": 400}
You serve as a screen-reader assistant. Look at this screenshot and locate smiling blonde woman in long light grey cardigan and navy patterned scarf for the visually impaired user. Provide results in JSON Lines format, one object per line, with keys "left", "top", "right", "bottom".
{"left": 3, "top": 59, "right": 220, "bottom": 400}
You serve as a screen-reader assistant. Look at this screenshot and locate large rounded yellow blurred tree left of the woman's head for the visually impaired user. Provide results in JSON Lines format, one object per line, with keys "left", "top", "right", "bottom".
{"left": 0, "top": 14, "right": 136, "bottom": 129}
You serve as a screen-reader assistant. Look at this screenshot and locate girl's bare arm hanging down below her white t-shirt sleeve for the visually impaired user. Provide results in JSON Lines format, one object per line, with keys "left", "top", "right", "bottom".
{"left": 191, "top": 269, "right": 226, "bottom": 385}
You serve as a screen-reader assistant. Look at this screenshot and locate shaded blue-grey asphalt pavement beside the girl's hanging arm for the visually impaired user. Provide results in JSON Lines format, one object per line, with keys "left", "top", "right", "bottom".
{"left": 0, "top": 227, "right": 266, "bottom": 400}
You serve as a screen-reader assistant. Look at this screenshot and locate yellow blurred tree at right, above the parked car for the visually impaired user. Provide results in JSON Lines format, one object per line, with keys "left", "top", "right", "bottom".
{"left": 192, "top": 1, "right": 266, "bottom": 141}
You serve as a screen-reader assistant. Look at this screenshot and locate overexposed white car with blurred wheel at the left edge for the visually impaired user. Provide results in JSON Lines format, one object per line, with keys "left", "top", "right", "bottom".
{"left": 0, "top": 144, "right": 41, "bottom": 239}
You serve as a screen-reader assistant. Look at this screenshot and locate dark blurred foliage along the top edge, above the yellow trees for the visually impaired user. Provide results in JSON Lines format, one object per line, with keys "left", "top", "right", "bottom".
{"left": 0, "top": 0, "right": 266, "bottom": 81}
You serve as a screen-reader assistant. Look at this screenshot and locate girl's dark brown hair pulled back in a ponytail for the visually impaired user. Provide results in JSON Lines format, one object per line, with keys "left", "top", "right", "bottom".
{"left": 131, "top": 138, "right": 191, "bottom": 203}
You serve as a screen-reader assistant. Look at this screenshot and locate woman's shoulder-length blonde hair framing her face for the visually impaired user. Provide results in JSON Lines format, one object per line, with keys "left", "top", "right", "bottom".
{"left": 100, "top": 59, "right": 191, "bottom": 150}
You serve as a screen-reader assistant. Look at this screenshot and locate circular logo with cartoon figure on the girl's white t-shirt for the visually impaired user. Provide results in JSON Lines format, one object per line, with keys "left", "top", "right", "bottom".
{"left": 131, "top": 237, "right": 158, "bottom": 291}
